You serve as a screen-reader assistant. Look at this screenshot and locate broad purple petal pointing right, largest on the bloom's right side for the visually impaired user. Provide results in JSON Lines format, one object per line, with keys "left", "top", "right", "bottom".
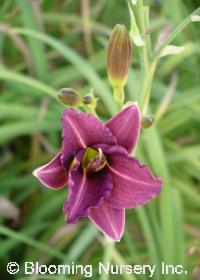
{"left": 105, "top": 154, "right": 162, "bottom": 209}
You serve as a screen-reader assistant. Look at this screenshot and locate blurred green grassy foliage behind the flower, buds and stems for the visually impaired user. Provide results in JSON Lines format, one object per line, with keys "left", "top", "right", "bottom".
{"left": 0, "top": 0, "right": 200, "bottom": 280}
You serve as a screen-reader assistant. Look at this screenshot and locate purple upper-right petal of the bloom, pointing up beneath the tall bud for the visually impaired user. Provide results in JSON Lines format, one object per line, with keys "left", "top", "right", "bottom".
{"left": 106, "top": 104, "right": 141, "bottom": 152}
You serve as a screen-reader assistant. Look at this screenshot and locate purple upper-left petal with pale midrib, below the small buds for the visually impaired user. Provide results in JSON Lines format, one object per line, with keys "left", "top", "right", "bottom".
{"left": 61, "top": 109, "right": 117, "bottom": 168}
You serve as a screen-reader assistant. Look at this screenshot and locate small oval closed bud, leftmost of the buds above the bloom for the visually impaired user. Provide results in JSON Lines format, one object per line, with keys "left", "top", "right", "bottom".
{"left": 58, "top": 88, "right": 81, "bottom": 106}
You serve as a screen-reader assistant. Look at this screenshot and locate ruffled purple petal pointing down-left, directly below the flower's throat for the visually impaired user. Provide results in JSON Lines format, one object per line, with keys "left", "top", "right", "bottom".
{"left": 64, "top": 165, "right": 113, "bottom": 223}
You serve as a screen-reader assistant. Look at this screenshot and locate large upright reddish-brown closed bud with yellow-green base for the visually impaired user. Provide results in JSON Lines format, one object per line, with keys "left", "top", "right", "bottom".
{"left": 107, "top": 24, "right": 131, "bottom": 88}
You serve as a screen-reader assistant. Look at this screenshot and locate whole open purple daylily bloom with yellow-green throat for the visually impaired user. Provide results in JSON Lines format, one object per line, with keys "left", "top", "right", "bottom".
{"left": 34, "top": 104, "right": 162, "bottom": 241}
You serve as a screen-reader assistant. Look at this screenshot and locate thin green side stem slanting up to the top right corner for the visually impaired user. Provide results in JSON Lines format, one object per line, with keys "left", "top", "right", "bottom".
{"left": 152, "top": 7, "right": 200, "bottom": 61}
